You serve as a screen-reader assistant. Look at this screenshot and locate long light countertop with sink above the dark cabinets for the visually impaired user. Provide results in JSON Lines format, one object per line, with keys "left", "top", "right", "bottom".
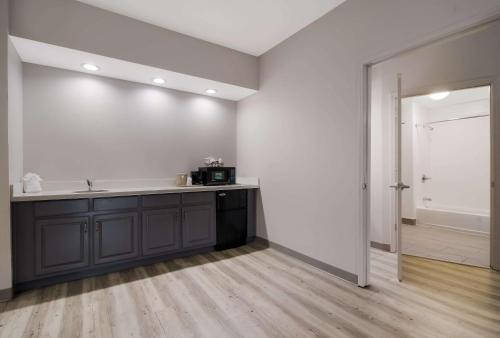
{"left": 10, "top": 178, "right": 259, "bottom": 202}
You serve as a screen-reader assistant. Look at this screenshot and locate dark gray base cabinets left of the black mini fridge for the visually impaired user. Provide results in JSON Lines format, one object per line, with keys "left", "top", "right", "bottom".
{"left": 12, "top": 192, "right": 254, "bottom": 290}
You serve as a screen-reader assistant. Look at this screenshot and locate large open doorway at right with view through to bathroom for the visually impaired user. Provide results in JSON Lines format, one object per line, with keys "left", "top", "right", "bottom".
{"left": 360, "top": 17, "right": 500, "bottom": 286}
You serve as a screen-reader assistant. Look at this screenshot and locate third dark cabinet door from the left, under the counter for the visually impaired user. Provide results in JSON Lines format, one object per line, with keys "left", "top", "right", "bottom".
{"left": 142, "top": 208, "right": 181, "bottom": 255}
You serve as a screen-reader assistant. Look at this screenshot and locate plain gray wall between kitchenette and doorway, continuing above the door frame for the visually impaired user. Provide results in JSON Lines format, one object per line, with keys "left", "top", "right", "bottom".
{"left": 238, "top": 0, "right": 500, "bottom": 273}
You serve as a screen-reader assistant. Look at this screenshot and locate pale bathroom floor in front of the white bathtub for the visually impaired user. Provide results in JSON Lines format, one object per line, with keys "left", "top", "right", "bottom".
{"left": 403, "top": 224, "right": 490, "bottom": 267}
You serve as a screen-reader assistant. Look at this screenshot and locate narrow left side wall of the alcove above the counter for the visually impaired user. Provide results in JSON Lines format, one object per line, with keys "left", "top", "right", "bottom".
{"left": 8, "top": 39, "right": 23, "bottom": 184}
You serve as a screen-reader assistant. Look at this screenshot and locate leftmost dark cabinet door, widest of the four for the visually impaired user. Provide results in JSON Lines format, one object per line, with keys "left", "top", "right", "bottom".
{"left": 35, "top": 217, "right": 89, "bottom": 275}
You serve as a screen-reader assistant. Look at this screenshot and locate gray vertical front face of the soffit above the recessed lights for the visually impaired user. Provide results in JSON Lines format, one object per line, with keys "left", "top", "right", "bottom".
{"left": 10, "top": 0, "right": 259, "bottom": 89}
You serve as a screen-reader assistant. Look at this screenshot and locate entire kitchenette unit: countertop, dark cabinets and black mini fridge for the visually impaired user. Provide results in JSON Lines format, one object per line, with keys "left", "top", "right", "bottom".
{"left": 11, "top": 179, "right": 259, "bottom": 291}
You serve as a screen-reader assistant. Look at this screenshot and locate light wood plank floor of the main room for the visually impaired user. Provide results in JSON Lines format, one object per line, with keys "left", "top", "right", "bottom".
{"left": 0, "top": 245, "right": 500, "bottom": 337}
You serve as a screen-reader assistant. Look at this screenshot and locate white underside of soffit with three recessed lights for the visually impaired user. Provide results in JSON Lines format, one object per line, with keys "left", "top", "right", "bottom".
{"left": 10, "top": 36, "right": 257, "bottom": 101}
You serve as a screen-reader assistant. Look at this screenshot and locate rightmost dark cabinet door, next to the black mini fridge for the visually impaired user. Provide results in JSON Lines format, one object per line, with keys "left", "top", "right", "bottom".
{"left": 182, "top": 204, "right": 215, "bottom": 248}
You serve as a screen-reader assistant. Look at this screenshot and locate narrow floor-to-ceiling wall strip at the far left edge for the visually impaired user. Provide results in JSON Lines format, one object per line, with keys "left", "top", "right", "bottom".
{"left": 0, "top": 0, "right": 12, "bottom": 300}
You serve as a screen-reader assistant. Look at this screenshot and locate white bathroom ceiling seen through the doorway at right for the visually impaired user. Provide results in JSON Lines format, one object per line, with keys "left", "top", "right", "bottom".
{"left": 404, "top": 86, "right": 490, "bottom": 109}
